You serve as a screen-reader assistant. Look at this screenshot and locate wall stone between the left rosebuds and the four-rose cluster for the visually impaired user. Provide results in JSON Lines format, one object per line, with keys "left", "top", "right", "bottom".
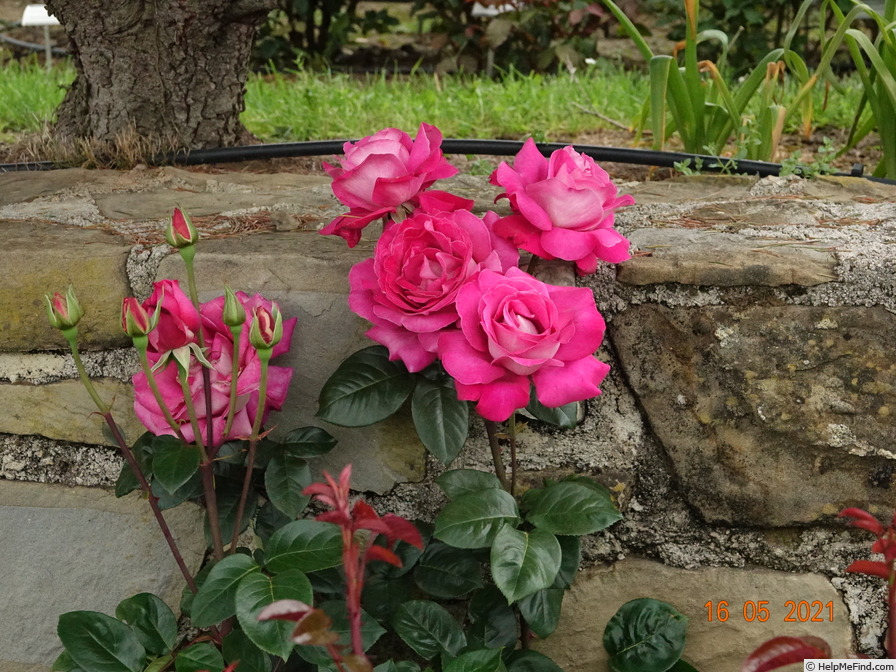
{"left": 157, "top": 232, "right": 425, "bottom": 493}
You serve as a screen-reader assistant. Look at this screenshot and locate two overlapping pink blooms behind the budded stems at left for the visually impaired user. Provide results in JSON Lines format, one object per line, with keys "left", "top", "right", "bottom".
{"left": 133, "top": 280, "right": 296, "bottom": 446}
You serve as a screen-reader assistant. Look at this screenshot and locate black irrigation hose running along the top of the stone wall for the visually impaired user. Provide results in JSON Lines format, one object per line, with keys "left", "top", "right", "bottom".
{"left": 0, "top": 138, "right": 896, "bottom": 185}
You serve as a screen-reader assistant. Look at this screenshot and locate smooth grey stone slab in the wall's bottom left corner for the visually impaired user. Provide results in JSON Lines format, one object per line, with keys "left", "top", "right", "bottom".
{"left": 0, "top": 480, "right": 205, "bottom": 672}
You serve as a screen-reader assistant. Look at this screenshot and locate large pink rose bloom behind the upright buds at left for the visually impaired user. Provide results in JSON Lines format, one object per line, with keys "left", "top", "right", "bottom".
{"left": 133, "top": 288, "right": 296, "bottom": 446}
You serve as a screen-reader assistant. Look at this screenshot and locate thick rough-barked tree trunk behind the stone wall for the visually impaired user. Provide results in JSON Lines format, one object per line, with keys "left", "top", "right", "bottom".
{"left": 46, "top": 0, "right": 275, "bottom": 149}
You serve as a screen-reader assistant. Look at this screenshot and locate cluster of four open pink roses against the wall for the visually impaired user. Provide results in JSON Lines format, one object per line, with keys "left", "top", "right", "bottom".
{"left": 322, "top": 124, "right": 634, "bottom": 421}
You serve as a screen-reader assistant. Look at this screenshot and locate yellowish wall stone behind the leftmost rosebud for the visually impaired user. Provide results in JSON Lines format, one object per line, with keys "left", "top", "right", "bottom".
{"left": 0, "top": 220, "right": 130, "bottom": 352}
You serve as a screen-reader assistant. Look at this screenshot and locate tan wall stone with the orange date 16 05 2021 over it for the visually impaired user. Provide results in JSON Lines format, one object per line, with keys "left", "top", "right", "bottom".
{"left": 535, "top": 558, "right": 852, "bottom": 672}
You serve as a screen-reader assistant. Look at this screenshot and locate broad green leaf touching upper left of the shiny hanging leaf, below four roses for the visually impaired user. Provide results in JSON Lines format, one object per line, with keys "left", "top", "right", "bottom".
{"left": 433, "top": 489, "right": 520, "bottom": 548}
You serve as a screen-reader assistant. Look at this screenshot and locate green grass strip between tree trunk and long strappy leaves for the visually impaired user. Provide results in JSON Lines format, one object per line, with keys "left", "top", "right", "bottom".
{"left": 243, "top": 62, "right": 647, "bottom": 141}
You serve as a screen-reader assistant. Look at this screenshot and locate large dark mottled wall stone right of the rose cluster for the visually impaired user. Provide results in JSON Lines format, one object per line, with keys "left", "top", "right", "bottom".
{"left": 611, "top": 304, "right": 896, "bottom": 526}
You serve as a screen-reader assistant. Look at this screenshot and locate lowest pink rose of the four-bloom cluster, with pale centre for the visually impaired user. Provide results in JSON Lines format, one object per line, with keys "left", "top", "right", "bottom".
{"left": 438, "top": 268, "right": 610, "bottom": 422}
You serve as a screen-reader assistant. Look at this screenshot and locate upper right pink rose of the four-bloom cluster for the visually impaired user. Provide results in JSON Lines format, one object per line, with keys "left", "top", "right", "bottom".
{"left": 490, "top": 138, "right": 635, "bottom": 275}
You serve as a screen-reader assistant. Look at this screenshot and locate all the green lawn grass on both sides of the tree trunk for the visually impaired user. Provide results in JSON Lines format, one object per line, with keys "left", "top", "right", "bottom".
{"left": 0, "top": 59, "right": 876, "bottom": 150}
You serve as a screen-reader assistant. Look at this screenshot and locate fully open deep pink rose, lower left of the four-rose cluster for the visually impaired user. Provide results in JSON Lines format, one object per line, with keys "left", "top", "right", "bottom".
{"left": 349, "top": 202, "right": 519, "bottom": 371}
